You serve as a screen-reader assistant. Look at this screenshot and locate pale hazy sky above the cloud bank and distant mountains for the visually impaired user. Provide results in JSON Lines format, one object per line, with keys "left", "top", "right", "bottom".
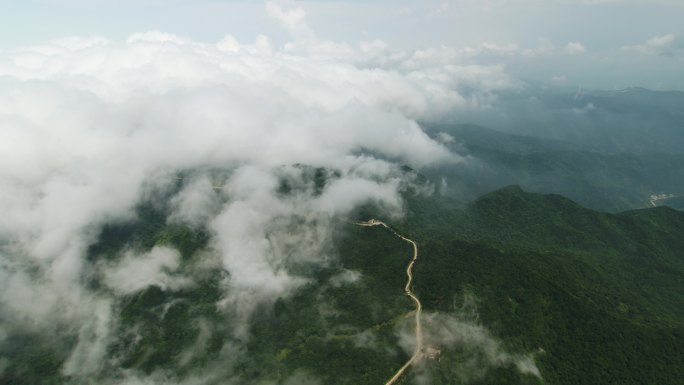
{"left": 0, "top": 0, "right": 684, "bottom": 90}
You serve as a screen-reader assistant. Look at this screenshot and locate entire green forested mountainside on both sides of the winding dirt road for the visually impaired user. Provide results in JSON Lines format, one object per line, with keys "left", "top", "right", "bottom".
{"left": 1, "top": 187, "right": 684, "bottom": 385}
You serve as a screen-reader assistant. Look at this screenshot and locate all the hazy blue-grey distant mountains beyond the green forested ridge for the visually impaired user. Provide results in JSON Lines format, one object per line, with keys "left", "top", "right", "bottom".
{"left": 423, "top": 84, "right": 684, "bottom": 212}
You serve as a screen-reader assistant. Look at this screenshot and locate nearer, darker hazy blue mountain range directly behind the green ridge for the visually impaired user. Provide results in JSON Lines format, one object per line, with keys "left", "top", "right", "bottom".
{"left": 425, "top": 124, "right": 684, "bottom": 212}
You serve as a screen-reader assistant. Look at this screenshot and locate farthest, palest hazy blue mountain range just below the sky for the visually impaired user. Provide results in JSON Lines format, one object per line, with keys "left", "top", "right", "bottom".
{"left": 448, "top": 84, "right": 684, "bottom": 154}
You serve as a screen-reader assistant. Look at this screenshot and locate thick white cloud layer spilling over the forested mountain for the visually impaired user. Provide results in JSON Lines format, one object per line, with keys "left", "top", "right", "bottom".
{"left": 0, "top": 4, "right": 512, "bottom": 376}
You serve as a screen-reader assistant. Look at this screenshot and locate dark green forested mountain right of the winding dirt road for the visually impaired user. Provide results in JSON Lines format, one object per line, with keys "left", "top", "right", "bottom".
{"left": 400, "top": 187, "right": 684, "bottom": 384}
